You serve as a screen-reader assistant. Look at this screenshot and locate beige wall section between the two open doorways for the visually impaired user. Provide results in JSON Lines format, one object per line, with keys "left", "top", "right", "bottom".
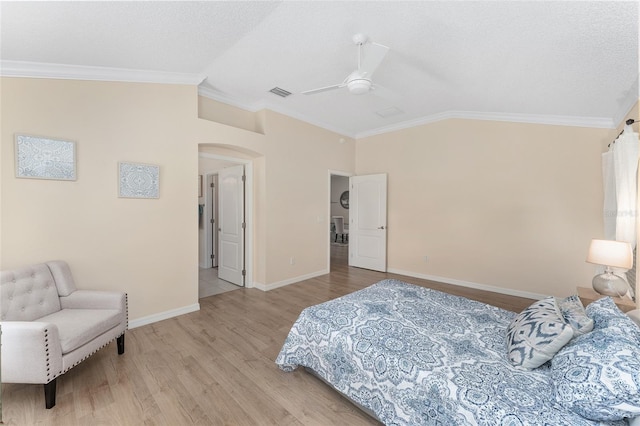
{"left": 199, "top": 103, "right": 355, "bottom": 289}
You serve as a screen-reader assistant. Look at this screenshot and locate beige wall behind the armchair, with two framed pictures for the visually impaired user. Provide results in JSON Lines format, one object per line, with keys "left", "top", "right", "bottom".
{"left": 0, "top": 78, "right": 198, "bottom": 320}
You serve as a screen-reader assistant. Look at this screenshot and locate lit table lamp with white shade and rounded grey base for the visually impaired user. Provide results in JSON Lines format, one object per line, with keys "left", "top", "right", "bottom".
{"left": 587, "top": 239, "right": 633, "bottom": 297}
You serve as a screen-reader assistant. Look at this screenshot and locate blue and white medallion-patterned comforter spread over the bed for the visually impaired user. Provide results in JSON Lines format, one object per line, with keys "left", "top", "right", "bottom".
{"left": 276, "top": 280, "right": 626, "bottom": 426}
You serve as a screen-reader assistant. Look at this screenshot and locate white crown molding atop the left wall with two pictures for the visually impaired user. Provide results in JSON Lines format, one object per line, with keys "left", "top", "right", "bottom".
{"left": 0, "top": 60, "right": 205, "bottom": 86}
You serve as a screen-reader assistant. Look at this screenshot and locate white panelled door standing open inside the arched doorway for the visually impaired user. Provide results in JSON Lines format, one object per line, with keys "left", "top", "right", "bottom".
{"left": 218, "top": 165, "right": 245, "bottom": 286}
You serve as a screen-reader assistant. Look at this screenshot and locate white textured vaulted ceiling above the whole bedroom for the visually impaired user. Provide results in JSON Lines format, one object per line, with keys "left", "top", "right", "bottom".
{"left": 0, "top": 1, "right": 639, "bottom": 137}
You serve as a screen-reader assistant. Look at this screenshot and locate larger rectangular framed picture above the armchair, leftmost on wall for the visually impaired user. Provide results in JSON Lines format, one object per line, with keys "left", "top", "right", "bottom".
{"left": 15, "top": 135, "right": 76, "bottom": 180}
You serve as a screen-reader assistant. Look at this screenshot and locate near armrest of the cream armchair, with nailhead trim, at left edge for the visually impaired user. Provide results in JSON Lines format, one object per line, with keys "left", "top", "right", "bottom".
{"left": 0, "top": 321, "right": 62, "bottom": 384}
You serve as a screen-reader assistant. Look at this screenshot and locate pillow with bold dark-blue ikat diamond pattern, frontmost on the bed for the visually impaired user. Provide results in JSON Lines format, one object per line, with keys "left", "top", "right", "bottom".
{"left": 507, "top": 297, "right": 573, "bottom": 369}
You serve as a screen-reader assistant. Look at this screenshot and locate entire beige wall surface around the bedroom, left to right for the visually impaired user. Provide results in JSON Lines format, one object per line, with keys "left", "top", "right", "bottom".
{"left": 0, "top": 78, "right": 637, "bottom": 321}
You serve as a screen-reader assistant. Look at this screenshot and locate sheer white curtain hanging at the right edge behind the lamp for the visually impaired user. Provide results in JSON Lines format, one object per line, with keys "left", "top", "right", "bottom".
{"left": 602, "top": 125, "right": 638, "bottom": 294}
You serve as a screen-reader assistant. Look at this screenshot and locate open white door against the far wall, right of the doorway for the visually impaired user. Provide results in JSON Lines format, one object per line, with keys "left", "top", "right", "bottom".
{"left": 349, "top": 173, "right": 387, "bottom": 272}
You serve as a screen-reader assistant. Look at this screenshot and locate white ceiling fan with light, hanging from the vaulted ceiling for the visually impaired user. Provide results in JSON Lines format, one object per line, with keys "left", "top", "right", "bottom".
{"left": 302, "top": 34, "right": 389, "bottom": 95}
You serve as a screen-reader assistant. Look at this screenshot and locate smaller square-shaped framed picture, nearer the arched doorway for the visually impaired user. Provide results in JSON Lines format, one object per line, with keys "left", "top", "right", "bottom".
{"left": 118, "top": 161, "right": 160, "bottom": 198}
